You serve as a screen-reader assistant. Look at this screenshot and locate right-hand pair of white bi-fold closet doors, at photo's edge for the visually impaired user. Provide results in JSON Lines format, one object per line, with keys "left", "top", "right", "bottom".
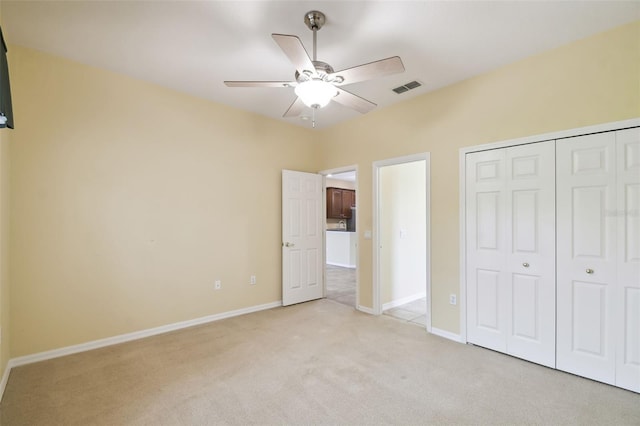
{"left": 556, "top": 128, "right": 640, "bottom": 392}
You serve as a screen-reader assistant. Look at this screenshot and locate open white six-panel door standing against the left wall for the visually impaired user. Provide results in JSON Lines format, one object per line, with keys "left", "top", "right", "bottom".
{"left": 282, "top": 170, "right": 324, "bottom": 306}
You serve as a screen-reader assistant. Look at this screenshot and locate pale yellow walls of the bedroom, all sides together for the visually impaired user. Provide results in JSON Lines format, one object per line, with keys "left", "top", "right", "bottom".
{"left": 5, "top": 23, "right": 640, "bottom": 365}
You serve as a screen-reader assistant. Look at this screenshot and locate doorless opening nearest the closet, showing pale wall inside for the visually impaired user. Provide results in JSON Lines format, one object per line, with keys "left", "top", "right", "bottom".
{"left": 373, "top": 153, "right": 431, "bottom": 331}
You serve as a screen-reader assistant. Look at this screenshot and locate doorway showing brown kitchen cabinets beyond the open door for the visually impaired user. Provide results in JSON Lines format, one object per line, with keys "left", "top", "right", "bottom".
{"left": 321, "top": 166, "right": 358, "bottom": 308}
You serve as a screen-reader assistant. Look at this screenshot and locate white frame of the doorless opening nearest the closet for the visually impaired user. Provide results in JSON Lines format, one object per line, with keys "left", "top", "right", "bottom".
{"left": 372, "top": 152, "right": 432, "bottom": 333}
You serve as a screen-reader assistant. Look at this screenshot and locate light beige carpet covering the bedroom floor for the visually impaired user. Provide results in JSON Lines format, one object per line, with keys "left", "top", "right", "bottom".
{"left": 0, "top": 299, "right": 640, "bottom": 425}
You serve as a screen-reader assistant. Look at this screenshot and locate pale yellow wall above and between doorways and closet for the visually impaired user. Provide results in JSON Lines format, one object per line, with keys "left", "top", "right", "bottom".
{"left": 316, "top": 22, "right": 640, "bottom": 333}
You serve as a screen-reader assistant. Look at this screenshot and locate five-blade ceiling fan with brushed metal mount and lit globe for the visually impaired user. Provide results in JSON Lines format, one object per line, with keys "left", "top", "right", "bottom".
{"left": 224, "top": 10, "right": 404, "bottom": 127}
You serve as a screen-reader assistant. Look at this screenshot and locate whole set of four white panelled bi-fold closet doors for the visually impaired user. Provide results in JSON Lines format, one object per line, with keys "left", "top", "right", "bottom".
{"left": 465, "top": 127, "right": 640, "bottom": 392}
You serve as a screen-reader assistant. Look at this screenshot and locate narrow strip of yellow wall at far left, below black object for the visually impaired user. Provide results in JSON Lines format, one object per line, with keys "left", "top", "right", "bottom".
{"left": 0, "top": 5, "right": 13, "bottom": 386}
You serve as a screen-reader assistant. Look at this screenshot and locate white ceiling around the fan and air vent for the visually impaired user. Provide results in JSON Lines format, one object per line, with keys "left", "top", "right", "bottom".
{"left": 1, "top": 0, "right": 640, "bottom": 128}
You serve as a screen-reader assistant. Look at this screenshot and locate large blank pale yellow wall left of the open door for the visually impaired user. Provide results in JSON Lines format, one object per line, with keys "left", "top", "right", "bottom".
{"left": 10, "top": 46, "right": 320, "bottom": 357}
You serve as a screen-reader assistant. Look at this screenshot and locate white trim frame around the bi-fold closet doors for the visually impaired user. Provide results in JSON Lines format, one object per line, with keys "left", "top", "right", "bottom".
{"left": 458, "top": 118, "right": 640, "bottom": 343}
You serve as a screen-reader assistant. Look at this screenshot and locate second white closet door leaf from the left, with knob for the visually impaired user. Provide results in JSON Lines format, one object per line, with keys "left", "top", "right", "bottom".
{"left": 505, "top": 141, "right": 556, "bottom": 367}
